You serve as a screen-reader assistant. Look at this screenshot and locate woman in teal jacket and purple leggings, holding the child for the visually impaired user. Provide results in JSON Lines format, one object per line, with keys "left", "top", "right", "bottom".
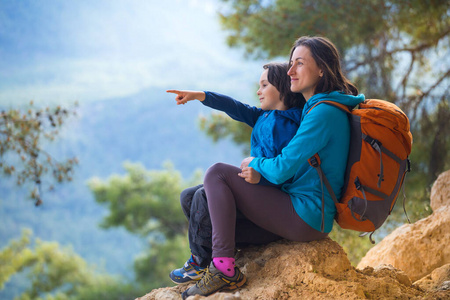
{"left": 182, "top": 37, "right": 364, "bottom": 298}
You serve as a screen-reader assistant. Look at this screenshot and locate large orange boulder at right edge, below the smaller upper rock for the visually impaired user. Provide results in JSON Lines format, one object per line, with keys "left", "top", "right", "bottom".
{"left": 357, "top": 206, "right": 450, "bottom": 281}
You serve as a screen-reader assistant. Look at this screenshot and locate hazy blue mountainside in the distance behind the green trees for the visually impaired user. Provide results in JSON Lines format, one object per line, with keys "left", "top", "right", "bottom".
{"left": 0, "top": 89, "right": 250, "bottom": 298}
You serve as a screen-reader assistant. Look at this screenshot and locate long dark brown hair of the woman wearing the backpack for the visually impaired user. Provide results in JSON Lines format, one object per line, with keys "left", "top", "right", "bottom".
{"left": 290, "top": 36, "right": 358, "bottom": 96}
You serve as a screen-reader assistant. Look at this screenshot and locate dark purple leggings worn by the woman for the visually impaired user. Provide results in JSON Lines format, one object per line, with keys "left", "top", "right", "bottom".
{"left": 204, "top": 163, "right": 328, "bottom": 257}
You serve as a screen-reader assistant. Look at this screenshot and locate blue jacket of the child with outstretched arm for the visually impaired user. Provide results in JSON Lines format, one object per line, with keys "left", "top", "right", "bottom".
{"left": 202, "top": 91, "right": 302, "bottom": 185}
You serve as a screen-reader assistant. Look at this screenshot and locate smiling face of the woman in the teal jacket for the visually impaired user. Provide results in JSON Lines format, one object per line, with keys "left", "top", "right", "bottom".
{"left": 288, "top": 46, "right": 323, "bottom": 101}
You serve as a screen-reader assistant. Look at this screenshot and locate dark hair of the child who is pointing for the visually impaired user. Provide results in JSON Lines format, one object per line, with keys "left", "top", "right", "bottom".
{"left": 263, "top": 62, "right": 306, "bottom": 109}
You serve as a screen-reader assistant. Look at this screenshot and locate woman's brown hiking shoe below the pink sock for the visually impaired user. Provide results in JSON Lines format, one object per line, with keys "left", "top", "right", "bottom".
{"left": 181, "top": 262, "right": 247, "bottom": 299}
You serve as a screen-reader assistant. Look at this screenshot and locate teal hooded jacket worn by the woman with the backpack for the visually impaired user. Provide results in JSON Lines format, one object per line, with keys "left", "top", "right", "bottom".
{"left": 249, "top": 91, "right": 364, "bottom": 232}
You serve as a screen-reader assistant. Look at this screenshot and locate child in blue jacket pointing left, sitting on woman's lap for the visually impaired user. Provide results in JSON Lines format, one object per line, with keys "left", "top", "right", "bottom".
{"left": 167, "top": 63, "right": 305, "bottom": 283}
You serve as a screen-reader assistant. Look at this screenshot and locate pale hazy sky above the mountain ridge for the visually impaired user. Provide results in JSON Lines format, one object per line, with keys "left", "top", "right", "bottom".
{"left": 0, "top": 0, "right": 263, "bottom": 105}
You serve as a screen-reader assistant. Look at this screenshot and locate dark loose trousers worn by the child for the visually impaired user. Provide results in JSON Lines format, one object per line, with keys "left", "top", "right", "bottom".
{"left": 180, "top": 184, "right": 281, "bottom": 267}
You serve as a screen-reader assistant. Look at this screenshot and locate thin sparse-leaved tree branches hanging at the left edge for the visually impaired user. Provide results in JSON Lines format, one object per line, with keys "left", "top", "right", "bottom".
{"left": 0, "top": 102, "right": 77, "bottom": 206}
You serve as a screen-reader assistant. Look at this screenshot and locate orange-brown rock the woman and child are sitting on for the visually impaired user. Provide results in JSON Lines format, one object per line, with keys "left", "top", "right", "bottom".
{"left": 139, "top": 238, "right": 426, "bottom": 300}
